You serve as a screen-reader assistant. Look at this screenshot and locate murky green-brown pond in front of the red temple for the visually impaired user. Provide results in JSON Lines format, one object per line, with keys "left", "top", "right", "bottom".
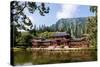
{"left": 14, "top": 49, "right": 97, "bottom": 66}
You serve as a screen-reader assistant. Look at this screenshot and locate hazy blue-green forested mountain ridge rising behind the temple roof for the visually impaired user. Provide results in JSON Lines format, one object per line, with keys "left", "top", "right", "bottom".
{"left": 50, "top": 17, "right": 92, "bottom": 37}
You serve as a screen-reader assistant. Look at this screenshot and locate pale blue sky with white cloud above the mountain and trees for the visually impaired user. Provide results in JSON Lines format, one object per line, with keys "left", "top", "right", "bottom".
{"left": 24, "top": 3, "right": 94, "bottom": 26}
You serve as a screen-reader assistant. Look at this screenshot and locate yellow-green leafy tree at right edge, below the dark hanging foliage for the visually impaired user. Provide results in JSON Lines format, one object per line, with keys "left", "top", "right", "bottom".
{"left": 87, "top": 17, "right": 97, "bottom": 47}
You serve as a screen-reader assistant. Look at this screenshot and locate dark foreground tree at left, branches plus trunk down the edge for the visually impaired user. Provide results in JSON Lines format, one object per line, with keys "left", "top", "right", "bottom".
{"left": 10, "top": 1, "right": 49, "bottom": 47}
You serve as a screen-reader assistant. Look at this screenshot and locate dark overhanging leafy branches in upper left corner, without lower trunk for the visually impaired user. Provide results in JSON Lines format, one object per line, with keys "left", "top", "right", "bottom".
{"left": 11, "top": 1, "right": 49, "bottom": 31}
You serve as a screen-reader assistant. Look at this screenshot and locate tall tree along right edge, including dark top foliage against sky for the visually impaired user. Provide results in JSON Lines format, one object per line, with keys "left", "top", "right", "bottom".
{"left": 87, "top": 6, "right": 97, "bottom": 48}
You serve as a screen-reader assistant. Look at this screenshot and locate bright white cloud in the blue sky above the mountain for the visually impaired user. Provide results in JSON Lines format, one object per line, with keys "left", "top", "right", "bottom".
{"left": 56, "top": 4, "right": 78, "bottom": 19}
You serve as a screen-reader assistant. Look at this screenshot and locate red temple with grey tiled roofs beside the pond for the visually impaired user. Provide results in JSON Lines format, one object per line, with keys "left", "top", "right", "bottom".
{"left": 32, "top": 32, "right": 89, "bottom": 48}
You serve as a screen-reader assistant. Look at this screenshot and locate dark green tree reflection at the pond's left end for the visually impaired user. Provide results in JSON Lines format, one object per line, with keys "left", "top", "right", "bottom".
{"left": 14, "top": 50, "right": 32, "bottom": 65}
